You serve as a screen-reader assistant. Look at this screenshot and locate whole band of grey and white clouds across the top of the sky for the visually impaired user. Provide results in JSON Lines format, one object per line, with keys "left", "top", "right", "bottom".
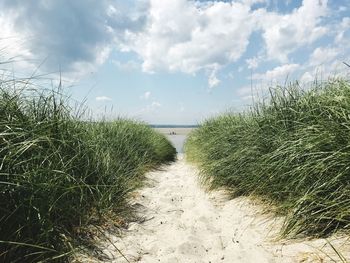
{"left": 0, "top": 0, "right": 344, "bottom": 88}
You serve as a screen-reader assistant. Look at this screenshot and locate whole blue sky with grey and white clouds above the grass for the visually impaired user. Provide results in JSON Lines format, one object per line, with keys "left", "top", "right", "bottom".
{"left": 0, "top": 0, "right": 350, "bottom": 124}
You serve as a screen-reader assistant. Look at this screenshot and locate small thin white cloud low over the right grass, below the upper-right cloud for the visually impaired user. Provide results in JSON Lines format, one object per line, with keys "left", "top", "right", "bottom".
{"left": 253, "top": 64, "right": 300, "bottom": 82}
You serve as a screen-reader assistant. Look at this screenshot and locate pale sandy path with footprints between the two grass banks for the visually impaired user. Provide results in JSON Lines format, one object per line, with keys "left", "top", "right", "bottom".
{"left": 76, "top": 157, "right": 350, "bottom": 263}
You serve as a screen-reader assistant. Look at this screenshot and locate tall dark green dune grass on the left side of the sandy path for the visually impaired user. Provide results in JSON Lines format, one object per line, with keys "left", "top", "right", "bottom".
{"left": 0, "top": 80, "right": 176, "bottom": 262}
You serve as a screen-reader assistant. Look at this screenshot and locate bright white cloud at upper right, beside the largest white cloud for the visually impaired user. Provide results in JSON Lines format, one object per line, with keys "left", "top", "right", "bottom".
{"left": 255, "top": 0, "right": 328, "bottom": 62}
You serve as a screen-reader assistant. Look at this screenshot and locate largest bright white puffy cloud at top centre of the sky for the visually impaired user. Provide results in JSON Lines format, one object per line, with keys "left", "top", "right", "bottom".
{"left": 123, "top": 0, "right": 255, "bottom": 83}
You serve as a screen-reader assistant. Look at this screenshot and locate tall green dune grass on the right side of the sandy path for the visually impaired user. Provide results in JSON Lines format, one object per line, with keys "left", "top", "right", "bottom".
{"left": 185, "top": 79, "right": 350, "bottom": 237}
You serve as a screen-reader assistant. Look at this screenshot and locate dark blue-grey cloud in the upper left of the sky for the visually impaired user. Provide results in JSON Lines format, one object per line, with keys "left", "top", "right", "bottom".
{"left": 0, "top": 0, "right": 146, "bottom": 74}
